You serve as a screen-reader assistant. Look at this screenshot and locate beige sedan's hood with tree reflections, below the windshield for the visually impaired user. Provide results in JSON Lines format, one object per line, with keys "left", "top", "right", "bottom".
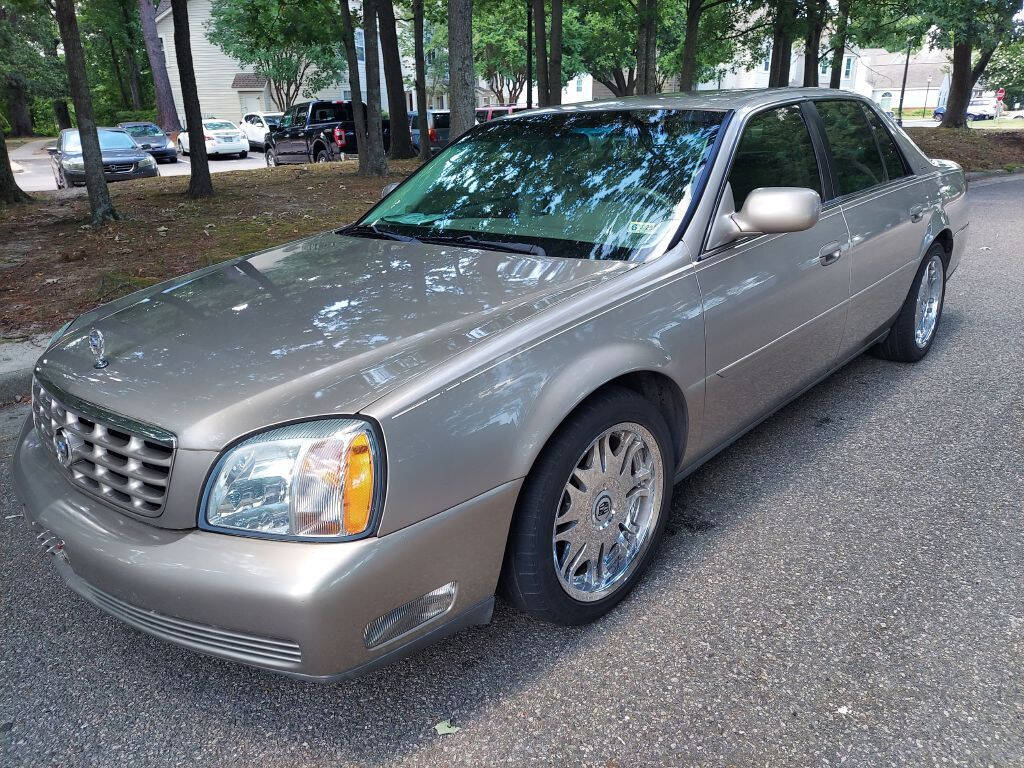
{"left": 37, "top": 232, "right": 632, "bottom": 450}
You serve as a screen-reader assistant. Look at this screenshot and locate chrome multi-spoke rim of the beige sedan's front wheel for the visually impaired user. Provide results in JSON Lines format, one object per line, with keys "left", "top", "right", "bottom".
{"left": 552, "top": 422, "right": 665, "bottom": 602}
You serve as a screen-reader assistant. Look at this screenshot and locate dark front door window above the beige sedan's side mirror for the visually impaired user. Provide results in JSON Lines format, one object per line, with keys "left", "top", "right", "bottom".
{"left": 729, "top": 104, "right": 821, "bottom": 211}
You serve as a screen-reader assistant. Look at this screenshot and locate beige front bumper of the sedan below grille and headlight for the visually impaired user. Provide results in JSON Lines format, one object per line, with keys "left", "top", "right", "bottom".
{"left": 13, "top": 424, "right": 520, "bottom": 679}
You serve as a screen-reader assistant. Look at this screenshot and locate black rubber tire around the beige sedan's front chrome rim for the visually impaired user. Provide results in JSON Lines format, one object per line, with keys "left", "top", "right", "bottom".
{"left": 502, "top": 387, "right": 675, "bottom": 625}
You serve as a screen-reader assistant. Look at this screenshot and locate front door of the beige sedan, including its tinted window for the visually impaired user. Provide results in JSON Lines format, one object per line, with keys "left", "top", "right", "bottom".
{"left": 696, "top": 104, "right": 850, "bottom": 449}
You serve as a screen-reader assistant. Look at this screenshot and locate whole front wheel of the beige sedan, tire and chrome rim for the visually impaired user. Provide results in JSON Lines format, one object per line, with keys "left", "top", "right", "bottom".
{"left": 502, "top": 387, "right": 673, "bottom": 625}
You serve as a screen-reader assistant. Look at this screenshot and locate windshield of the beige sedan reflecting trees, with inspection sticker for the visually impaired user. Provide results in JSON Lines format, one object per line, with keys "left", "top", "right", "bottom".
{"left": 359, "top": 110, "right": 724, "bottom": 259}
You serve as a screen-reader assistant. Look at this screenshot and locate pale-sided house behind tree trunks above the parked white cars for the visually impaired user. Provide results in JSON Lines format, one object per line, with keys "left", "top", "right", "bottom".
{"left": 157, "top": 0, "right": 409, "bottom": 121}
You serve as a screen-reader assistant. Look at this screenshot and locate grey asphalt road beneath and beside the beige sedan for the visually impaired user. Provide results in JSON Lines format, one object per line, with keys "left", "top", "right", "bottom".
{"left": 0, "top": 180, "right": 1024, "bottom": 768}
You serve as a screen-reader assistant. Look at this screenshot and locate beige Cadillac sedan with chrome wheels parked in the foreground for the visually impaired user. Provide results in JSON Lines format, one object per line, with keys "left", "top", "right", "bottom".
{"left": 14, "top": 88, "right": 968, "bottom": 678}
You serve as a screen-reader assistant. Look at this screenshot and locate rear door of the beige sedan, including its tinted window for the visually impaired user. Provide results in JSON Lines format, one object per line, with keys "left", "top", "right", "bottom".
{"left": 814, "top": 98, "right": 939, "bottom": 355}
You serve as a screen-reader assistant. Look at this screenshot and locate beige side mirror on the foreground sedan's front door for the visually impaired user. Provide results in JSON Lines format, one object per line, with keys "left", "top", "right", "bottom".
{"left": 709, "top": 186, "right": 821, "bottom": 248}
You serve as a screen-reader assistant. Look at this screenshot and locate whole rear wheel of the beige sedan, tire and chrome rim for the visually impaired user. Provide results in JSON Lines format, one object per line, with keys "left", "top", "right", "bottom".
{"left": 873, "top": 243, "right": 946, "bottom": 362}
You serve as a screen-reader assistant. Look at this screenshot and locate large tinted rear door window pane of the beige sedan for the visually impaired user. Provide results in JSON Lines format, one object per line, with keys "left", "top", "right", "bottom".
{"left": 814, "top": 99, "right": 888, "bottom": 195}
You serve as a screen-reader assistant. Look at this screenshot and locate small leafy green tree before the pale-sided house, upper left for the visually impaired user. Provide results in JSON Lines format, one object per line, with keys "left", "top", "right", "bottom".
{"left": 206, "top": 0, "right": 345, "bottom": 110}
